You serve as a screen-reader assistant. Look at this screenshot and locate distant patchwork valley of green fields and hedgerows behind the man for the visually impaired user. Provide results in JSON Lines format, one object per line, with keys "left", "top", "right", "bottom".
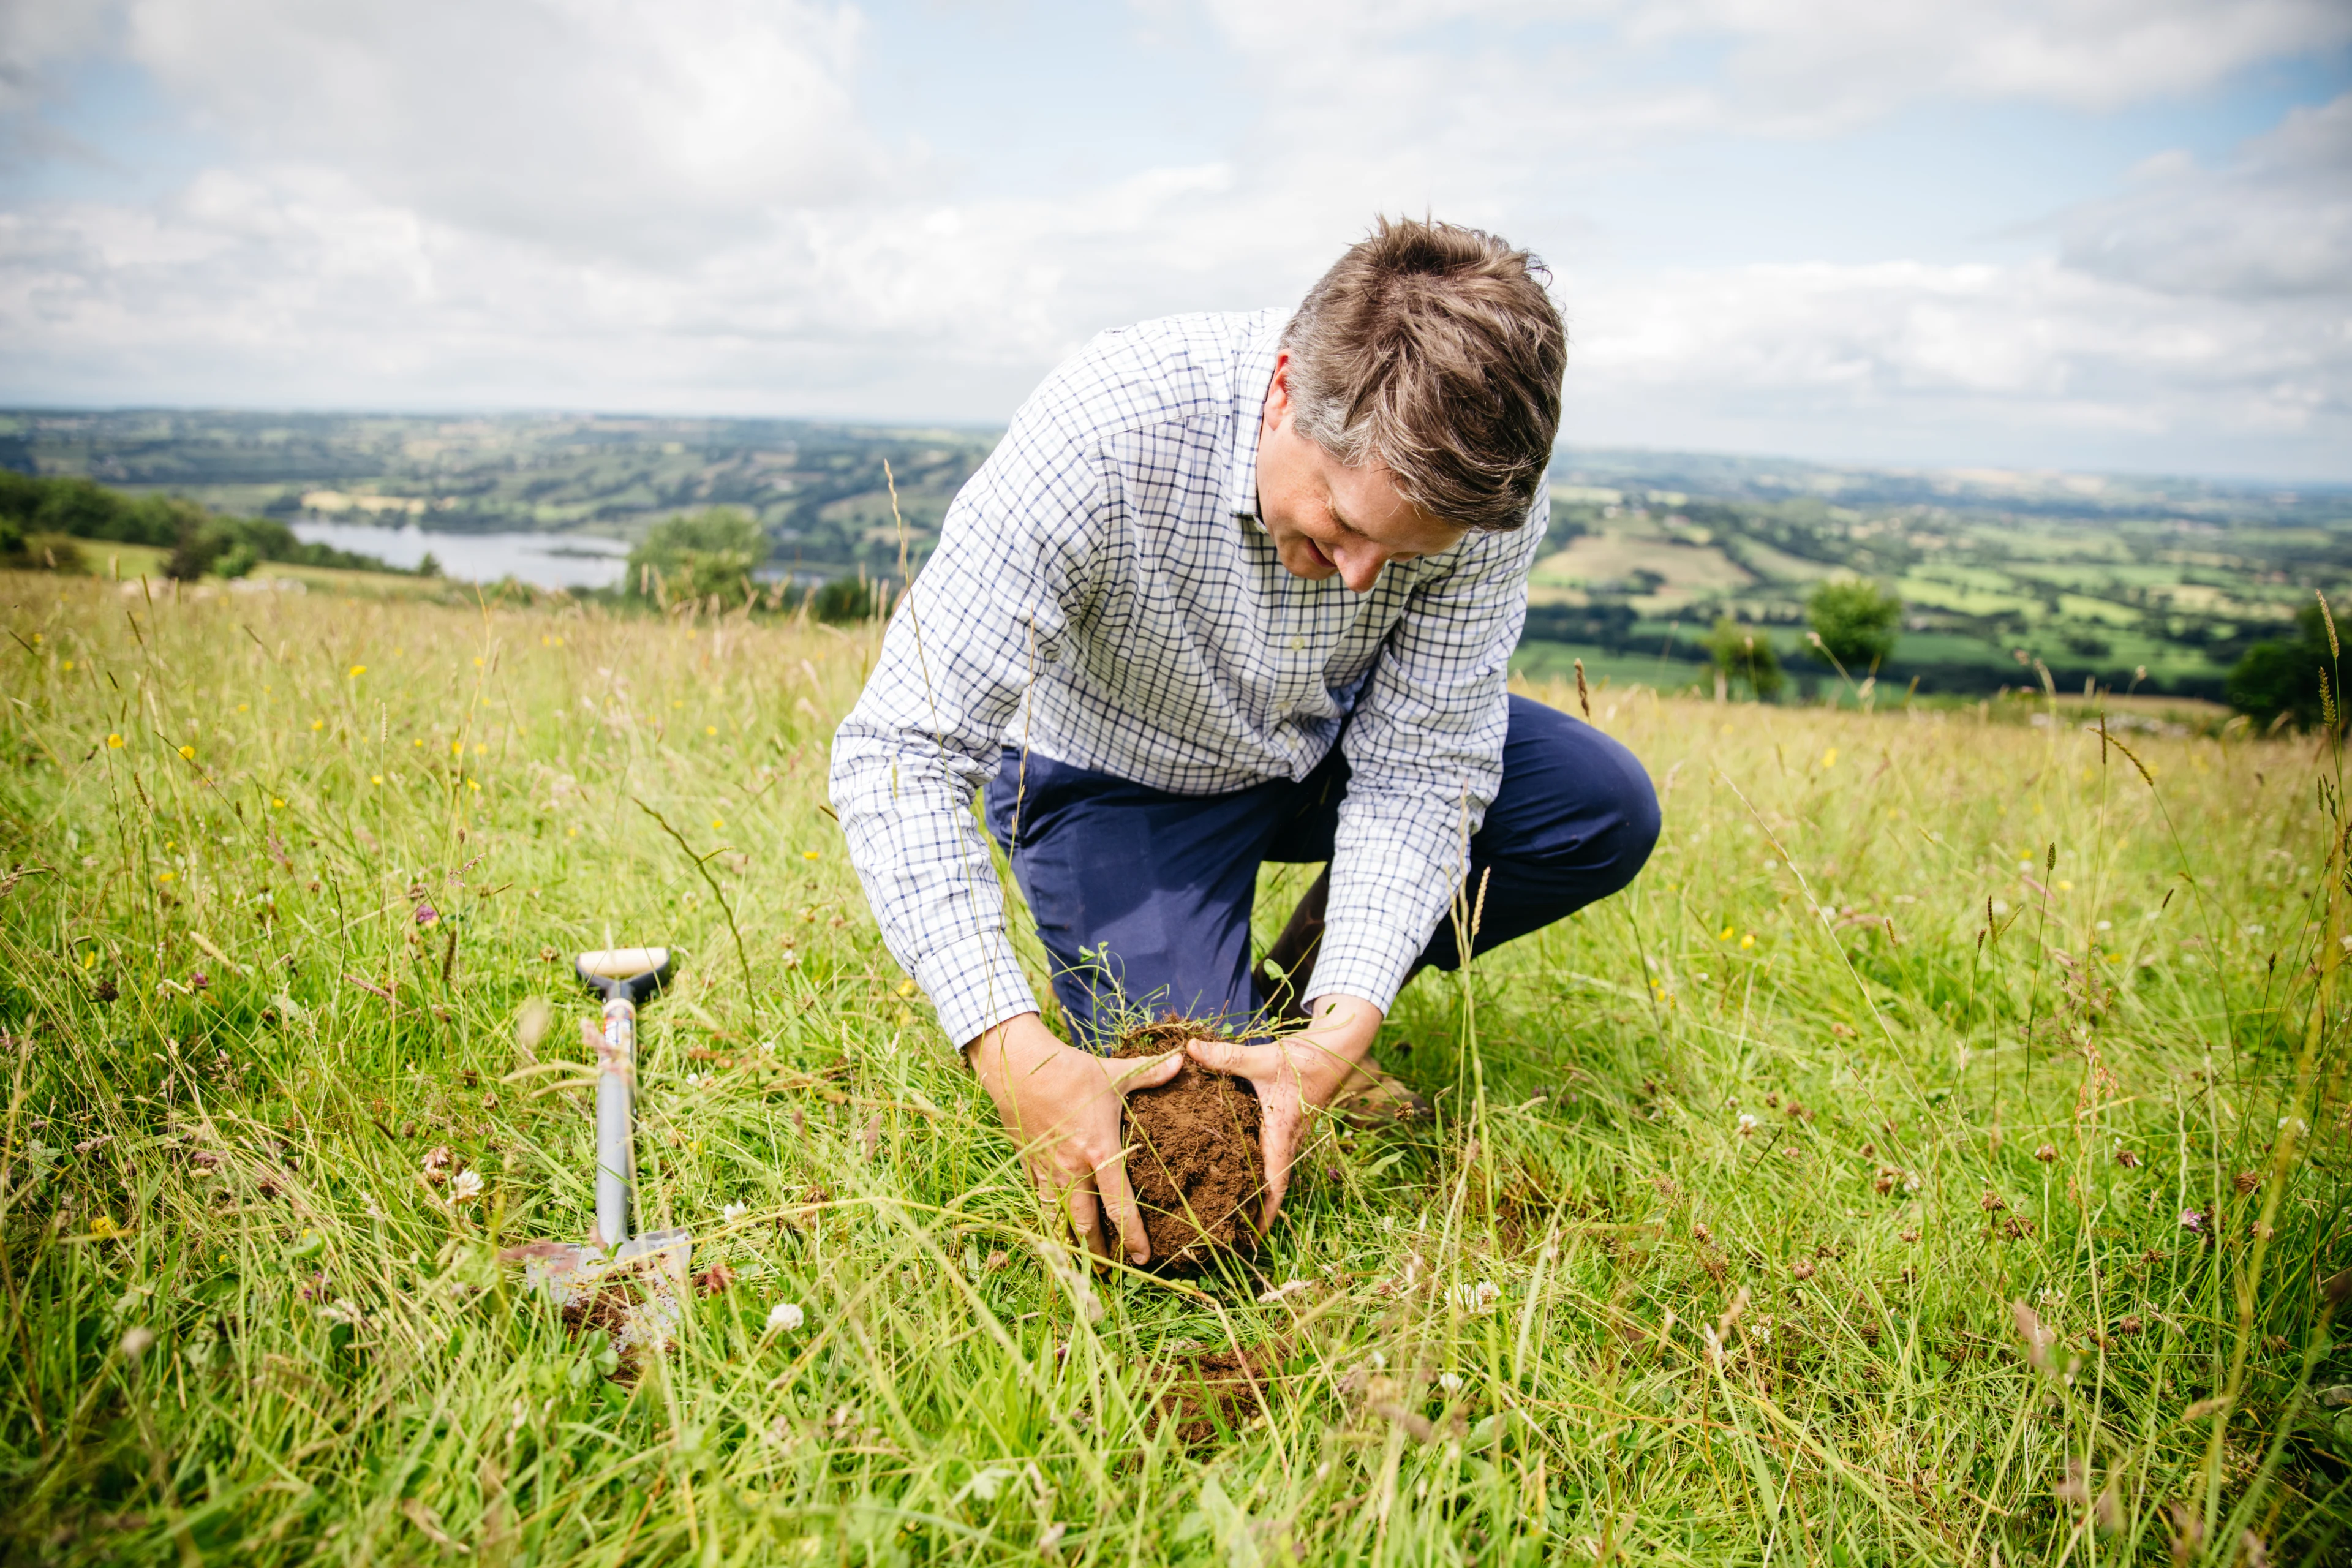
{"left": 18, "top": 412, "right": 2352, "bottom": 701}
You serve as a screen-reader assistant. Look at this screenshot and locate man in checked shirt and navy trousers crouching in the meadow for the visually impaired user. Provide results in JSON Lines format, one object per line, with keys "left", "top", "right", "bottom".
{"left": 832, "top": 221, "right": 1658, "bottom": 1262}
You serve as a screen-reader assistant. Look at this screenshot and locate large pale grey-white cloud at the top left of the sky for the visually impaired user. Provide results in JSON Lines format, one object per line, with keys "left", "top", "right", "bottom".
{"left": 127, "top": 0, "right": 884, "bottom": 256}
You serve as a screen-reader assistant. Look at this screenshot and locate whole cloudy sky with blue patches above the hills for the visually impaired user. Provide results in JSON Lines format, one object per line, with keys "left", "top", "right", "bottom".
{"left": 0, "top": 0, "right": 2352, "bottom": 482}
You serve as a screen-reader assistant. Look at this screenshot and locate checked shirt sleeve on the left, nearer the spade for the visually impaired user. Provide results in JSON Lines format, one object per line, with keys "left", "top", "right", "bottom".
{"left": 832, "top": 392, "right": 1110, "bottom": 1046}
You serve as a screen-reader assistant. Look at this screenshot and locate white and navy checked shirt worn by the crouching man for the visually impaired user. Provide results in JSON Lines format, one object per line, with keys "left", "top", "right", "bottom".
{"left": 832, "top": 311, "right": 1550, "bottom": 1046}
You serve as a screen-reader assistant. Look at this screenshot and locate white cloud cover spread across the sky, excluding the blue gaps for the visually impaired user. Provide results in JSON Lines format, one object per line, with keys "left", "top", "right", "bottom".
{"left": 0, "top": 0, "right": 2352, "bottom": 472}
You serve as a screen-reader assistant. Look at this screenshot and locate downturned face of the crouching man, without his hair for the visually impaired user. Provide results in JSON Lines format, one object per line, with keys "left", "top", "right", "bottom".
{"left": 1258, "top": 350, "right": 1468, "bottom": 592}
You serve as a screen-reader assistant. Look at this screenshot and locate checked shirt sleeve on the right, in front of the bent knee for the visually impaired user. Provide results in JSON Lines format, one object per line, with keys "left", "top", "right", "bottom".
{"left": 1308, "top": 491, "right": 1552, "bottom": 1011}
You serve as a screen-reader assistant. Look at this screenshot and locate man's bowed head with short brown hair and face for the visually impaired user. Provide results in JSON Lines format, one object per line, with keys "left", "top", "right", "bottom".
{"left": 1258, "top": 219, "right": 1569, "bottom": 592}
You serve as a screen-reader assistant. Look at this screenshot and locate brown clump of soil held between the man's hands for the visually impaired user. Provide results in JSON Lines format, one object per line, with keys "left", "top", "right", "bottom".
{"left": 1112, "top": 1018, "right": 1265, "bottom": 1274}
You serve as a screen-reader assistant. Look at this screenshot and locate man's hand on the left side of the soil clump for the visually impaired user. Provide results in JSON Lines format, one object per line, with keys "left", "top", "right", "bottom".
{"left": 964, "top": 1013, "right": 1183, "bottom": 1265}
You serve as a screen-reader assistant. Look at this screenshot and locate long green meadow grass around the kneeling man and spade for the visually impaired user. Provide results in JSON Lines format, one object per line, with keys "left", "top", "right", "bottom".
{"left": 0, "top": 576, "right": 2352, "bottom": 1566}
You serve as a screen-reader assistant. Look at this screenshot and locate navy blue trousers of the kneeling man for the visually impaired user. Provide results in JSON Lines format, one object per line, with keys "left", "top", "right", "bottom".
{"left": 986, "top": 696, "right": 1658, "bottom": 1039}
